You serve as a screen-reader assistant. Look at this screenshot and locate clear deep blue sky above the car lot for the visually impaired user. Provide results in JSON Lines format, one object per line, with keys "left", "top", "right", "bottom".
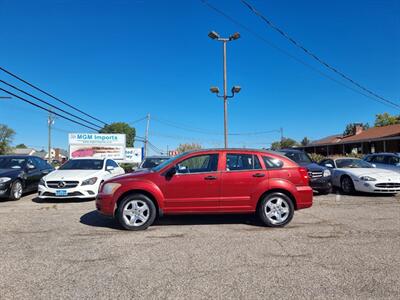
{"left": 0, "top": 0, "right": 400, "bottom": 154}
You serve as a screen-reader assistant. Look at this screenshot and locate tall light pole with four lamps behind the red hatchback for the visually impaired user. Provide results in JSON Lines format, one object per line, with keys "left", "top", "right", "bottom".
{"left": 208, "top": 31, "right": 241, "bottom": 148}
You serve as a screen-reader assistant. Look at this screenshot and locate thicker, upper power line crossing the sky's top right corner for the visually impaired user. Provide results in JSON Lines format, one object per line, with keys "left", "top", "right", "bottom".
{"left": 240, "top": 0, "right": 398, "bottom": 106}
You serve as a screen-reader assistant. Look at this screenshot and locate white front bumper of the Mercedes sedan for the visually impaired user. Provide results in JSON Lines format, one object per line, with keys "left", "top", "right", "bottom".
{"left": 38, "top": 185, "right": 99, "bottom": 199}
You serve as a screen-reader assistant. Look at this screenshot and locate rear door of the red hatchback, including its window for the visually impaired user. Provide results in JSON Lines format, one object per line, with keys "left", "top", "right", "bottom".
{"left": 220, "top": 152, "right": 267, "bottom": 212}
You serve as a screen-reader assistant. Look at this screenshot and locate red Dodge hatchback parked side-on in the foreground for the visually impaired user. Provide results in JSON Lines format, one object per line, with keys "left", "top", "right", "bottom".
{"left": 96, "top": 149, "right": 313, "bottom": 230}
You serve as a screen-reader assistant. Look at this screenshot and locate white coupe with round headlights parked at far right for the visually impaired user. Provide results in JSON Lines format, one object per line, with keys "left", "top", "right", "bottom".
{"left": 320, "top": 157, "right": 400, "bottom": 194}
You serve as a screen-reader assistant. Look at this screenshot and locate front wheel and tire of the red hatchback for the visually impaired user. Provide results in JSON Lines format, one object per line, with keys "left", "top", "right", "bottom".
{"left": 116, "top": 194, "right": 157, "bottom": 231}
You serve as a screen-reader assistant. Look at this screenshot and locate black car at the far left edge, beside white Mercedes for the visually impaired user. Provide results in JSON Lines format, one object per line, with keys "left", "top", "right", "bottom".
{"left": 0, "top": 155, "right": 54, "bottom": 200}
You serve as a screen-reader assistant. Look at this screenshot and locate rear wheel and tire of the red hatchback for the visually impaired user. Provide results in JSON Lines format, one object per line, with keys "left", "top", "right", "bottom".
{"left": 257, "top": 192, "right": 294, "bottom": 227}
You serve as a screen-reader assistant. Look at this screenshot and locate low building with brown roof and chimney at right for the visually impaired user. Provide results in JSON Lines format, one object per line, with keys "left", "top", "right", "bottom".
{"left": 301, "top": 124, "right": 400, "bottom": 156}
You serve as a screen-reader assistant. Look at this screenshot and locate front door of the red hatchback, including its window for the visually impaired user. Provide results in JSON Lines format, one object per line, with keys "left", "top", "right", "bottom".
{"left": 160, "top": 153, "right": 221, "bottom": 213}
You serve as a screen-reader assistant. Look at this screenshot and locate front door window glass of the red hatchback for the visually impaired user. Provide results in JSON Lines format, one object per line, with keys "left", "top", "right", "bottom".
{"left": 176, "top": 154, "right": 218, "bottom": 174}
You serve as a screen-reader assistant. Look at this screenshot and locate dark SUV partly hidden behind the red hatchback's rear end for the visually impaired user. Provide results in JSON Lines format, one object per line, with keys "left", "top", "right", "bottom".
{"left": 279, "top": 149, "right": 332, "bottom": 194}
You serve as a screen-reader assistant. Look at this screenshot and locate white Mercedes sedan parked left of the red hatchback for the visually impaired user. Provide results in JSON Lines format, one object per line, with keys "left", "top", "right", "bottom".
{"left": 38, "top": 158, "right": 125, "bottom": 199}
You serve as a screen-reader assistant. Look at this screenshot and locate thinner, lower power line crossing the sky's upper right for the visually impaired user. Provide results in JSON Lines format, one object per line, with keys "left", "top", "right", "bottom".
{"left": 200, "top": 0, "right": 400, "bottom": 109}
